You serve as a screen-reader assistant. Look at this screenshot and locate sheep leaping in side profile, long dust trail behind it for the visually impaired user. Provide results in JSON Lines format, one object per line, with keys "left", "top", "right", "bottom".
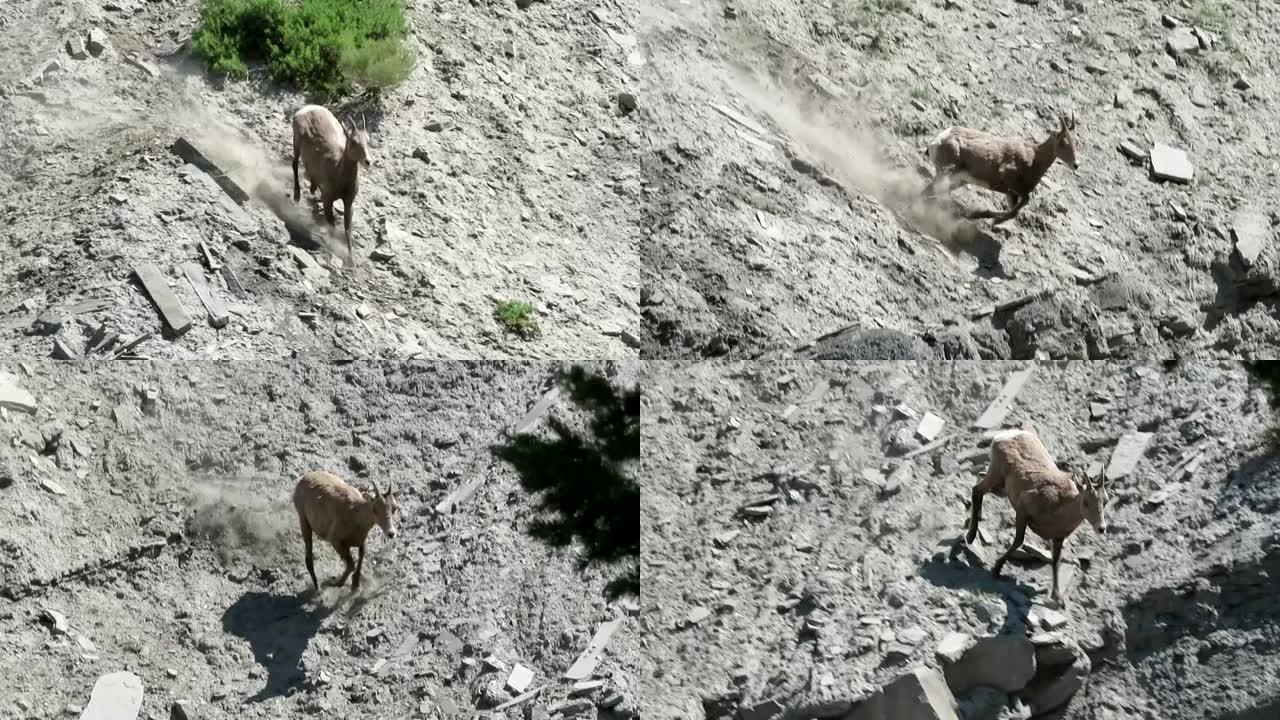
{"left": 924, "top": 113, "right": 1080, "bottom": 225}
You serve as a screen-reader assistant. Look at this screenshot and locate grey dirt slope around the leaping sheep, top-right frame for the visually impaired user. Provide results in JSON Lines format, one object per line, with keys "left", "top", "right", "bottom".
{"left": 640, "top": 0, "right": 1280, "bottom": 360}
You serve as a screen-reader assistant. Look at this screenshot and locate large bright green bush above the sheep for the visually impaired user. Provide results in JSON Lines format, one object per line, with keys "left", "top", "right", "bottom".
{"left": 191, "top": 0, "right": 413, "bottom": 100}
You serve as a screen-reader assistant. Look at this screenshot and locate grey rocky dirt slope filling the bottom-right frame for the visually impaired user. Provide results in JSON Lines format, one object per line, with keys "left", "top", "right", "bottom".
{"left": 640, "top": 361, "right": 1280, "bottom": 720}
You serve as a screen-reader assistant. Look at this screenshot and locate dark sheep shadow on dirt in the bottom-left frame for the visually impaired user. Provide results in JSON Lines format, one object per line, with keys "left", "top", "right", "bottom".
{"left": 223, "top": 591, "right": 332, "bottom": 702}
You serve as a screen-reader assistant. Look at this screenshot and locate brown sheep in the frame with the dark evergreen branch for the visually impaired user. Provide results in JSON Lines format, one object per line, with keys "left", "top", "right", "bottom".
{"left": 293, "top": 470, "right": 396, "bottom": 592}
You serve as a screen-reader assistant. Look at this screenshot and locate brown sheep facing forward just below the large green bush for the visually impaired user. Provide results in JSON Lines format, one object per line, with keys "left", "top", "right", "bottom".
{"left": 293, "top": 105, "right": 370, "bottom": 264}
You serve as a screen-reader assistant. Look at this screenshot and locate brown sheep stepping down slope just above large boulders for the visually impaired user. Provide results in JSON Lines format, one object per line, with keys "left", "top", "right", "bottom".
{"left": 965, "top": 430, "right": 1108, "bottom": 606}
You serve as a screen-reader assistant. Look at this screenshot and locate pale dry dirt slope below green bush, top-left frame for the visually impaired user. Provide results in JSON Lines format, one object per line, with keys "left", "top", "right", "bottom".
{"left": 0, "top": 0, "right": 644, "bottom": 359}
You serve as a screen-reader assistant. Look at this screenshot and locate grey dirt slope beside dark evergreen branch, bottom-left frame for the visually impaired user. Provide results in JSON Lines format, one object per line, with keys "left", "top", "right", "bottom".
{"left": 0, "top": 361, "right": 640, "bottom": 720}
